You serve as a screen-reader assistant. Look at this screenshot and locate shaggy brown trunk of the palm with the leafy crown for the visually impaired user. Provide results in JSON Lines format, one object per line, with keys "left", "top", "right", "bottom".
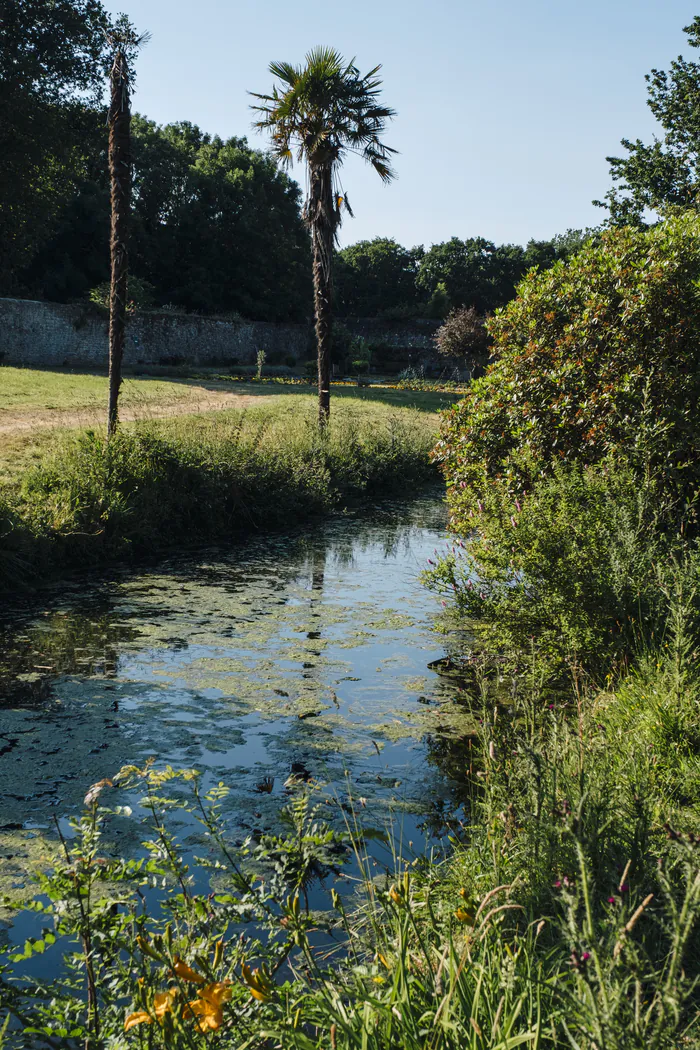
{"left": 304, "top": 164, "right": 338, "bottom": 429}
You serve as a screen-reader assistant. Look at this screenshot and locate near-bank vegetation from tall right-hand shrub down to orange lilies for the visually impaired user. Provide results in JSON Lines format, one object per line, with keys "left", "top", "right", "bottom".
{"left": 2, "top": 216, "right": 700, "bottom": 1050}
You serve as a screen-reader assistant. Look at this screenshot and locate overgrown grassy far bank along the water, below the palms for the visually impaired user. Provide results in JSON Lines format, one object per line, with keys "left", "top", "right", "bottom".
{"left": 0, "top": 392, "right": 436, "bottom": 587}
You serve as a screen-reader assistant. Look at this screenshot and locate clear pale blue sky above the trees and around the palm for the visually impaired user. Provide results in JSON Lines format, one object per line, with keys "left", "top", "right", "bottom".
{"left": 106, "top": 0, "right": 700, "bottom": 245}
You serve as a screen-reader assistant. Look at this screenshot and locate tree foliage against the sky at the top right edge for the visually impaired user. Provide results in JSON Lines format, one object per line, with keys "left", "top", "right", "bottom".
{"left": 594, "top": 16, "right": 700, "bottom": 226}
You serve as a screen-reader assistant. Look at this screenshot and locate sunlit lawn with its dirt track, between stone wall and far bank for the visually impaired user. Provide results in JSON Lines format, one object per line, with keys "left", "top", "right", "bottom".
{"left": 0, "top": 366, "right": 454, "bottom": 485}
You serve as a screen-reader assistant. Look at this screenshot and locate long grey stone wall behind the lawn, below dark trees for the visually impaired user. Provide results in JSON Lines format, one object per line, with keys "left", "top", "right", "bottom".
{"left": 0, "top": 299, "right": 438, "bottom": 369}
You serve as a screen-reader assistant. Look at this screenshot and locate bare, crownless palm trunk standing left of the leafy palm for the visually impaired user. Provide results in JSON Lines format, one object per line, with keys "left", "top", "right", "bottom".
{"left": 107, "top": 48, "right": 131, "bottom": 438}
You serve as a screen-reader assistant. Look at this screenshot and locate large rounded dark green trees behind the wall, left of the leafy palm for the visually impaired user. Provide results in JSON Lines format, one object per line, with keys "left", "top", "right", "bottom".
{"left": 32, "top": 116, "right": 311, "bottom": 320}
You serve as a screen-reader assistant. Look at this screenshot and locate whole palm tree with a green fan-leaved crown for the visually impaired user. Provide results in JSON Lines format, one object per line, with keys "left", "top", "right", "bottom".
{"left": 253, "top": 47, "right": 396, "bottom": 427}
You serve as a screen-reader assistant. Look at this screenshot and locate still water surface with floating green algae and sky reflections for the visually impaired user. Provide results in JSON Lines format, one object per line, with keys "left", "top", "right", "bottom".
{"left": 0, "top": 499, "right": 476, "bottom": 885}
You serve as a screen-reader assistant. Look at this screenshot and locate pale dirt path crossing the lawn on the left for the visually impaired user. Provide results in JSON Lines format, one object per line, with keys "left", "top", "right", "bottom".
{"left": 0, "top": 386, "right": 260, "bottom": 434}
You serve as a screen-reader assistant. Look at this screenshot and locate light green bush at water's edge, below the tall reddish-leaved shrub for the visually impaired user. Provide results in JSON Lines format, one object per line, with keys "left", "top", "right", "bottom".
{"left": 429, "top": 464, "right": 700, "bottom": 677}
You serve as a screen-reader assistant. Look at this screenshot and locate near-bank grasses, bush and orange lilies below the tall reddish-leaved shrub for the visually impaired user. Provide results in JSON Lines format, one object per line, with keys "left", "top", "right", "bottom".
{"left": 0, "top": 471, "right": 700, "bottom": 1050}
